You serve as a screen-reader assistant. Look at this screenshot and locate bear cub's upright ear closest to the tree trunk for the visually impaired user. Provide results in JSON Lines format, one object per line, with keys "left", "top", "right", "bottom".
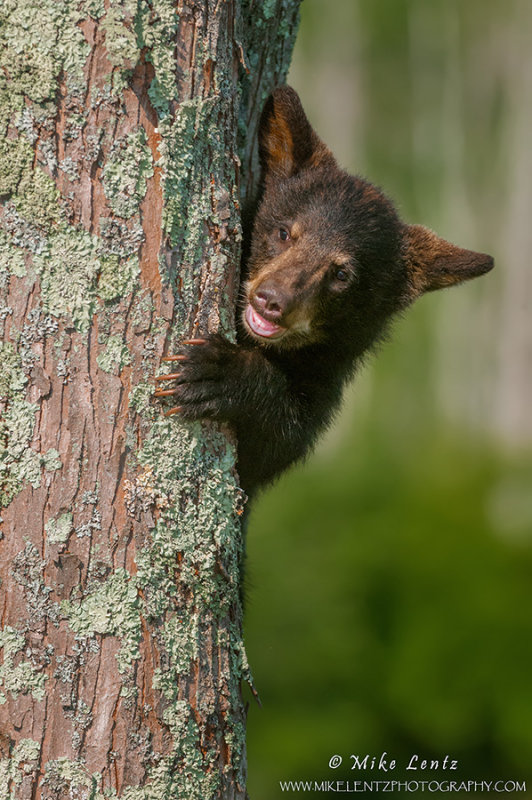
{"left": 259, "top": 86, "right": 337, "bottom": 181}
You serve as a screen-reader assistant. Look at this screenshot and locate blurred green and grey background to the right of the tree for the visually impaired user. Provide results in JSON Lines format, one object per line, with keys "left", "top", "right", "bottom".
{"left": 246, "top": 0, "right": 532, "bottom": 800}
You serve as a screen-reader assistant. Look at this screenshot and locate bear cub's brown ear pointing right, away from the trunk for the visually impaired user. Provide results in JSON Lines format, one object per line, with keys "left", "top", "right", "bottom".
{"left": 403, "top": 225, "right": 493, "bottom": 299}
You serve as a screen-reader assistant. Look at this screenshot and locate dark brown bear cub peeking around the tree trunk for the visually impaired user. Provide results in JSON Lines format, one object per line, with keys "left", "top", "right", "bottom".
{"left": 156, "top": 86, "right": 493, "bottom": 496}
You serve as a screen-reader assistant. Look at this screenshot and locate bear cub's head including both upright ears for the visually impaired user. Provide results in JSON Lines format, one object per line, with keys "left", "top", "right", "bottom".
{"left": 243, "top": 86, "right": 493, "bottom": 355}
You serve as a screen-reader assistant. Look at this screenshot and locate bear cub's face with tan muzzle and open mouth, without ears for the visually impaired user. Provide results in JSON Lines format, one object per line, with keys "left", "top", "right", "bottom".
{"left": 244, "top": 166, "right": 405, "bottom": 348}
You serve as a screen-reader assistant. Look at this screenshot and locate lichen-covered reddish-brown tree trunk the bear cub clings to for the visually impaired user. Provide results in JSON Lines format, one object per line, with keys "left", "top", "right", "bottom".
{"left": 0, "top": 0, "right": 298, "bottom": 800}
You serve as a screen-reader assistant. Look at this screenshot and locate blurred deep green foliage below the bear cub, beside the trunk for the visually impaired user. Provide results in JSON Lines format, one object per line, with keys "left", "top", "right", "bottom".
{"left": 247, "top": 412, "right": 532, "bottom": 800}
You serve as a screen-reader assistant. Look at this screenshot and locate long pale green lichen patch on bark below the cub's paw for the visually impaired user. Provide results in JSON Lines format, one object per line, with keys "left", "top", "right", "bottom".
{"left": 130, "top": 419, "right": 247, "bottom": 800}
